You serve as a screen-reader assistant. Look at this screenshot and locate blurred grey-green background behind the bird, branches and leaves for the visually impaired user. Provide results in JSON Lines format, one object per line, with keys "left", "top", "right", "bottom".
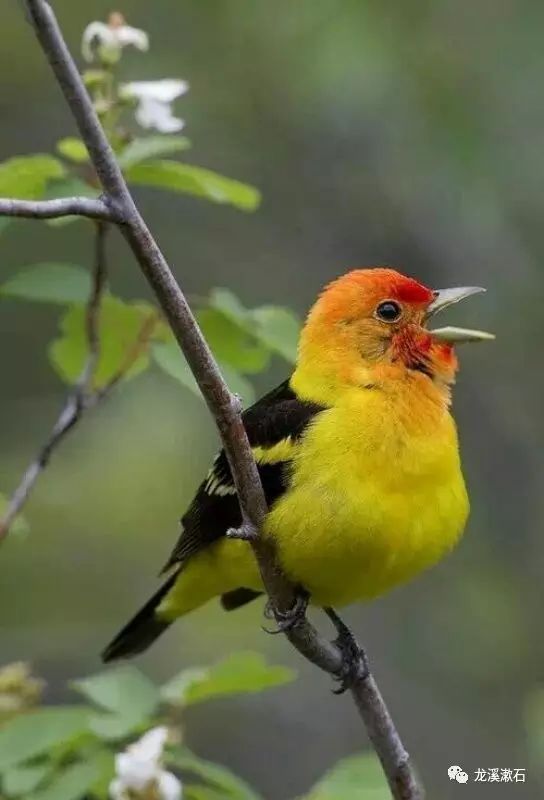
{"left": 0, "top": 0, "right": 544, "bottom": 800}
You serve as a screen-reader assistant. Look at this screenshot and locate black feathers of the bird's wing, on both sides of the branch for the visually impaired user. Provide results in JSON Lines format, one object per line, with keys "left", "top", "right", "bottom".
{"left": 163, "top": 380, "right": 323, "bottom": 571}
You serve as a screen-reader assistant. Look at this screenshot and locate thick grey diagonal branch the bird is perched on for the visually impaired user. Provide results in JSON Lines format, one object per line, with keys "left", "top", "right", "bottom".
{"left": 3, "top": 0, "right": 423, "bottom": 800}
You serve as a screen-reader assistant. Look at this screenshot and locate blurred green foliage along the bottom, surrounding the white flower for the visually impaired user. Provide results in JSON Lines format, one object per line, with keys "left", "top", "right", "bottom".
{"left": 0, "top": 653, "right": 388, "bottom": 800}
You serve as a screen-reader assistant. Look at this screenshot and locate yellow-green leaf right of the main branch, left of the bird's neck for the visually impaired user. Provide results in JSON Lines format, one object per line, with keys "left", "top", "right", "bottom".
{"left": 196, "top": 308, "right": 270, "bottom": 374}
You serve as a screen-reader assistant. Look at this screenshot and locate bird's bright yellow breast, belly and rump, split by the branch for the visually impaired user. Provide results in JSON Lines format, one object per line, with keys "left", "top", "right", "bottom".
{"left": 159, "top": 384, "right": 468, "bottom": 616}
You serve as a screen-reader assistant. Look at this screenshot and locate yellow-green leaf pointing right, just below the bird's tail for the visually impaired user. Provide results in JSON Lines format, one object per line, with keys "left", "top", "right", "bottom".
{"left": 161, "top": 653, "right": 296, "bottom": 705}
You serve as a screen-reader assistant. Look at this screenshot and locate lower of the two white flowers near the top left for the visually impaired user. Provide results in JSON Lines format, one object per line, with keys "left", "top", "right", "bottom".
{"left": 120, "top": 78, "right": 189, "bottom": 133}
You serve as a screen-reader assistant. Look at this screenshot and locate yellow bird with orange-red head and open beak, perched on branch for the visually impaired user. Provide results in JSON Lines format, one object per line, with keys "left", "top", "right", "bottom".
{"left": 102, "top": 267, "right": 494, "bottom": 662}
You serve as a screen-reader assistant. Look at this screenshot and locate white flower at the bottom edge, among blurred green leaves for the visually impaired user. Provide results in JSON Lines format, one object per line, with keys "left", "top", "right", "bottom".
{"left": 109, "top": 727, "right": 182, "bottom": 800}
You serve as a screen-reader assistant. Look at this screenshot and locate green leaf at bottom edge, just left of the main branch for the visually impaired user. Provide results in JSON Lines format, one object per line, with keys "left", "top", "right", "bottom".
{"left": 304, "top": 753, "right": 391, "bottom": 800}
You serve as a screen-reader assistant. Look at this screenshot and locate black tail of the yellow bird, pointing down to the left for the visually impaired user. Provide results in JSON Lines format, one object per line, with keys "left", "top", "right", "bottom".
{"left": 102, "top": 573, "right": 178, "bottom": 663}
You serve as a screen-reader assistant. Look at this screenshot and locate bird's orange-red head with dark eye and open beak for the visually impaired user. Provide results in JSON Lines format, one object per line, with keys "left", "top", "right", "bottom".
{"left": 297, "top": 268, "right": 493, "bottom": 406}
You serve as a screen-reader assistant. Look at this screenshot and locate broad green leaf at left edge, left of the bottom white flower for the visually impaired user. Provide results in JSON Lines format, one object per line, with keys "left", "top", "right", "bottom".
{"left": 0, "top": 706, "right": 90, "bottom": 771}
